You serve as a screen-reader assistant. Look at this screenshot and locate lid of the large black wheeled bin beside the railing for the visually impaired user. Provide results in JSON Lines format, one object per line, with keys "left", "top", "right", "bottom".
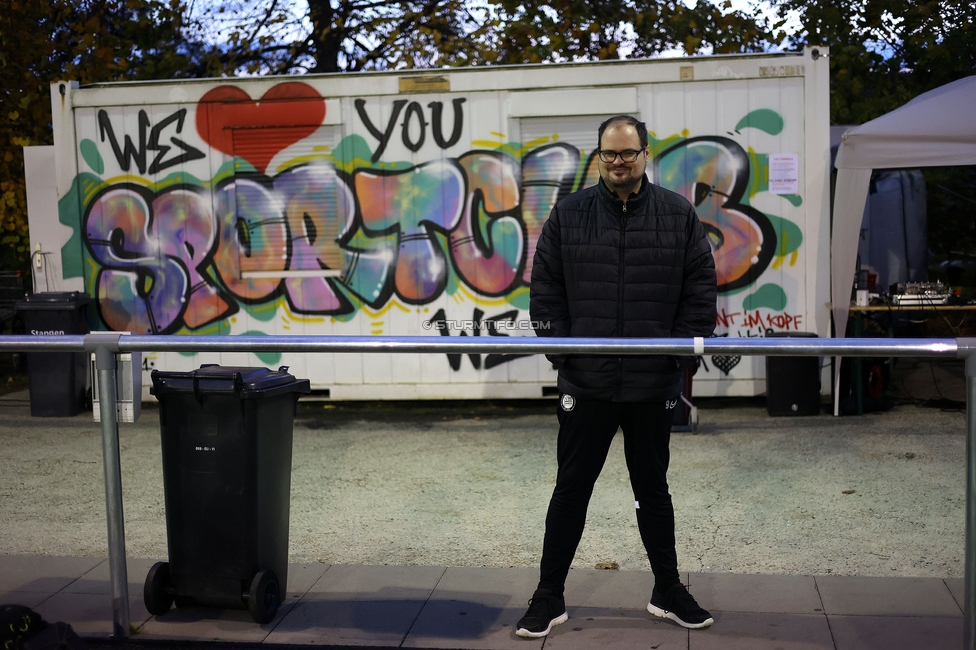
{"left": 150, "top": 364, "right": 311, "bottom": 398}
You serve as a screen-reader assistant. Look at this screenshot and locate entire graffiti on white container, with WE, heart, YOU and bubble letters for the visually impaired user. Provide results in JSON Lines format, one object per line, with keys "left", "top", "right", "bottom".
{"left": 70, "top": 82, "right": 802, "bottom": 362}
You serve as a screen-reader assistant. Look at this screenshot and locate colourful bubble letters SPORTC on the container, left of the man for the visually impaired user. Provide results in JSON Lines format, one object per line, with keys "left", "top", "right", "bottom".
{"left": 78, "top": 140, "right": 580, "bottom": 333}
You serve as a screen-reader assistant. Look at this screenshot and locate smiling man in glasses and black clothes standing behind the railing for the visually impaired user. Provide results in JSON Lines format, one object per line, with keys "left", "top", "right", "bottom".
{"left": 516, "top": 115, "right": 716, "bottom": 638}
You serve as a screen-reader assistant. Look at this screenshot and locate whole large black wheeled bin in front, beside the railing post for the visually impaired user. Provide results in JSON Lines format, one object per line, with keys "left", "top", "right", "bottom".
{"left": 143, "top": 365, "right": 309, "bottom": 623}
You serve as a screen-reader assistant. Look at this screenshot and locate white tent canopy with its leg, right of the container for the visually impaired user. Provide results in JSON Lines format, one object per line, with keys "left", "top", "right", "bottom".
{"left": 830, "top": 75, "right": 976, "bottom": 413}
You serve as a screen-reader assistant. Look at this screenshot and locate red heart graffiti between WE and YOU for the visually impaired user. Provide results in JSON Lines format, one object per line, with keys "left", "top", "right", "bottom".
{"left": 197, "top": 81, "right": 325, "bottom": 172}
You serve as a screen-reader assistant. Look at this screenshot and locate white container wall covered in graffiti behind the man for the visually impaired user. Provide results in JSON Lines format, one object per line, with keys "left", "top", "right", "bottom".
{"left": 40, "top": 48, "right": 830, "bottom": 400}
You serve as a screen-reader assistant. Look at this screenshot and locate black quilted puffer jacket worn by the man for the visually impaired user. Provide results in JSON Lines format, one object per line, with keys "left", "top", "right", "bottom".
{"left": 529, "top": 178, "right": 716, "bottom": 402}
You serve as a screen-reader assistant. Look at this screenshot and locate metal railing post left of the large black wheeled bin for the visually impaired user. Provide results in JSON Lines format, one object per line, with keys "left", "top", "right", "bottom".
{"left": 85, "top": 332, "right": 130, "bottom": 639}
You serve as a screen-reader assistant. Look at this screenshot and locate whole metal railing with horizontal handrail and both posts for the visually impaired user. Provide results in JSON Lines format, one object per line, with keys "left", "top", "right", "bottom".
{"left": 0, "top": 332, "right": 976, "bottom": 650}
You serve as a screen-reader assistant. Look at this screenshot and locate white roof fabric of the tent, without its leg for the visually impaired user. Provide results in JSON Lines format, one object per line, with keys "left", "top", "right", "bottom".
{"left": 836, "top": 75, "right": 976, "bottom": 169}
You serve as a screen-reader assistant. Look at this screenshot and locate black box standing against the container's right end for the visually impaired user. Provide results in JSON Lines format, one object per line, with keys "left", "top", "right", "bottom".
{"left": 766, "top": 332, "right": 820, "bottom": 415}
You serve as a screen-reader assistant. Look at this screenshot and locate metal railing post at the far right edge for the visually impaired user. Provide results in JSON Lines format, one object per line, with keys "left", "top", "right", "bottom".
{"left": 956, "top": 339, "right": 976, "bottom": 650}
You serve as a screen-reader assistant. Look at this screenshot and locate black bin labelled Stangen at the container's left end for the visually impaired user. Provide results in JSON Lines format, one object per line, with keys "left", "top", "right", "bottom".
{"left": 16, "top": 291, "right": 91, "bottom": 417}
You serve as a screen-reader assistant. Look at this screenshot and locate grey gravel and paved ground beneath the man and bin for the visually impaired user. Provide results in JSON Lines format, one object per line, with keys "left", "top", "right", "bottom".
{"left": 0, "top": 356, "right": 965, "bottom": 650}
